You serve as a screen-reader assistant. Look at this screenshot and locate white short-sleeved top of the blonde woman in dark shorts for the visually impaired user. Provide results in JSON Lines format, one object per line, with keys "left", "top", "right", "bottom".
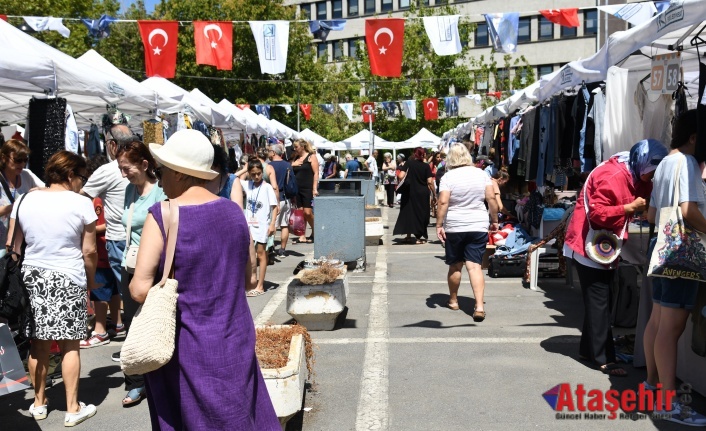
{"left": 439, "top": 166, "right": 492, "bottom": 232}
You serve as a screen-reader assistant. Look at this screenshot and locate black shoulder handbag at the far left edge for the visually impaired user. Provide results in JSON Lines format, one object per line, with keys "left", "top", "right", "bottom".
{"left": 0, "top": 193, "right": 31, "bottom": 321}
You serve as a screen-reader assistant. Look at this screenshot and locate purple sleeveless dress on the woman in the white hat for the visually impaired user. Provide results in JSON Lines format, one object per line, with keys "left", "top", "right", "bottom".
{"left": 145, "top": 198, "right": 282, "bottom": 431}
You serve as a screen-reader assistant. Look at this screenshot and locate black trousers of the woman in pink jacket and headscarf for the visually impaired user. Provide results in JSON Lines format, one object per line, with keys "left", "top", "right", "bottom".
{"left": 574, "top": 261, "right": 615, "bottom": 365}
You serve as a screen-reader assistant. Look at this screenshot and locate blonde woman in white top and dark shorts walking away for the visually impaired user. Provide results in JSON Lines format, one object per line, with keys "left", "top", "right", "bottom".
{"left": 436, "top": 144, "right": 498, "bottom": 322}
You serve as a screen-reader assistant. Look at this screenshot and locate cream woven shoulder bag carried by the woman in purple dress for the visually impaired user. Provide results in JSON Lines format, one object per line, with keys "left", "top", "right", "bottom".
{"left": 120, "top": 199, "right": 179, "bottom": 375}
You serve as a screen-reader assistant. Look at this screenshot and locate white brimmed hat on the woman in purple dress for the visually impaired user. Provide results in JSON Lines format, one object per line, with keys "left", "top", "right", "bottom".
{"left": 149, "top": 129, "right": 218, "bottom": 180}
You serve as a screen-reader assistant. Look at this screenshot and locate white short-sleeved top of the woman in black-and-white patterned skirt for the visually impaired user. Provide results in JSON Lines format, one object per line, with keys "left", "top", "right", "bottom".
{"left": 11, "top": 190, "right": 98, "bottom": 288}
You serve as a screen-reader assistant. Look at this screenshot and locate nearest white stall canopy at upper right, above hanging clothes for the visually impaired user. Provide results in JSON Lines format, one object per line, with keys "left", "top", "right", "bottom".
{"left": 538, "top": 0, "right": 706, "bottom": 100}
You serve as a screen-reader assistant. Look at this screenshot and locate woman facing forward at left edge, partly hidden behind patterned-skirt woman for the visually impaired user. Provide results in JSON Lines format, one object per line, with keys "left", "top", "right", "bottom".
{"left": 0, "top": 139, "right": 44, "bottom": 256}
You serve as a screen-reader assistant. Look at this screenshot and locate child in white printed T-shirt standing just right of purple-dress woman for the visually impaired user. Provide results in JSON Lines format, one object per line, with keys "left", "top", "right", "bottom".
{"left": 241, "top": 158, "right": 279, "bottom": 297}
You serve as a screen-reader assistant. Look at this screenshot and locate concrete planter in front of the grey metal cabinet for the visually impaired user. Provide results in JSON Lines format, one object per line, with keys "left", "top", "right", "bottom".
{"left": 287, "top": 269, "right": 348, "bottom": 331}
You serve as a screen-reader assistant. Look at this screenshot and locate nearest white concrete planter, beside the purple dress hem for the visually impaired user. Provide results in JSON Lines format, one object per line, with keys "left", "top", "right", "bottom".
{"left": 261, "top": 325, "right": 307, "bottom": 430}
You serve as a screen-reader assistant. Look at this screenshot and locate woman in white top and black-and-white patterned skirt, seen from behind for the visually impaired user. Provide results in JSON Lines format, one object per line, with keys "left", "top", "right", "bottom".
{"left": 6, "top": 151, "right": 98, "bottom": 426}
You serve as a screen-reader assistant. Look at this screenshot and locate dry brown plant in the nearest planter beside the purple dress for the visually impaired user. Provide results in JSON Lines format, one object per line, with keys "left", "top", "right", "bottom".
{"left": 255, "top": 324, "right": 315, "bottom": 380}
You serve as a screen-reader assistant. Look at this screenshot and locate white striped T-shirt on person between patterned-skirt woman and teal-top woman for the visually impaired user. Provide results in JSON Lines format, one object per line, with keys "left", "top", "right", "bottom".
{"left": 83, "top": 160, "right": 130, "bottom": 241}
